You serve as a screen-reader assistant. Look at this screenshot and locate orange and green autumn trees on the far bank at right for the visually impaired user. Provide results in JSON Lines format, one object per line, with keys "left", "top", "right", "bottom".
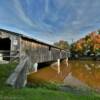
{"left": 71, "top": 31, "right": 100, "bottom": 55}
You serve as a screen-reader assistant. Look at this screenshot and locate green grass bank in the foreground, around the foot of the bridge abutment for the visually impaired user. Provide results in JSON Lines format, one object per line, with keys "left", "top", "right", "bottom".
{"left": 0, "top": 64, "right": 100, "bottom": 100}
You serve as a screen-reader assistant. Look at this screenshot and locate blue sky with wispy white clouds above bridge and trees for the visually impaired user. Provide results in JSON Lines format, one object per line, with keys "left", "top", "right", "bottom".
{"left": 0, "top": 0, "right": 100, "bottom": 44}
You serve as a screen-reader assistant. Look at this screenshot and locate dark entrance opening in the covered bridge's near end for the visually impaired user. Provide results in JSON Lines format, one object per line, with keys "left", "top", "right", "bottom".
{"left": 0, "top": 38, "right": 11, "bottom": 60}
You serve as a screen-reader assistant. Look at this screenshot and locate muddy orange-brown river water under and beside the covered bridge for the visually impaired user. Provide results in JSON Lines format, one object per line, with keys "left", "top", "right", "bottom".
{"left": 28, "top": 60, "right": 100, "bottom": 89}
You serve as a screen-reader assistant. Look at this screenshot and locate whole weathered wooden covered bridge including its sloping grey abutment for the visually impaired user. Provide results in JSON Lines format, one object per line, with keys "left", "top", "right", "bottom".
{"left": 0, "top": 29, "right": 68, "bottom": 87}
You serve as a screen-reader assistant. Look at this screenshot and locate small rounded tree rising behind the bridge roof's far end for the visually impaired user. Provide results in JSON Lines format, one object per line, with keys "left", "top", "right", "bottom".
{"left": 54, "top": 40, "right": 69, "bottom": 49}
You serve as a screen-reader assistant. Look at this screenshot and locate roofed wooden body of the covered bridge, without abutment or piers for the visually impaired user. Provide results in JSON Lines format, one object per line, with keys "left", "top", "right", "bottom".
{"left": 0, "top": 29, "right": 67, "bottom": 63}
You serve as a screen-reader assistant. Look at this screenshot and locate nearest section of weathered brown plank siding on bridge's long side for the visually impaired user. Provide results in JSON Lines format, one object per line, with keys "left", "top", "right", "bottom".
{"left": 21, "top": 39, "right": 49, "bottom": 62}
